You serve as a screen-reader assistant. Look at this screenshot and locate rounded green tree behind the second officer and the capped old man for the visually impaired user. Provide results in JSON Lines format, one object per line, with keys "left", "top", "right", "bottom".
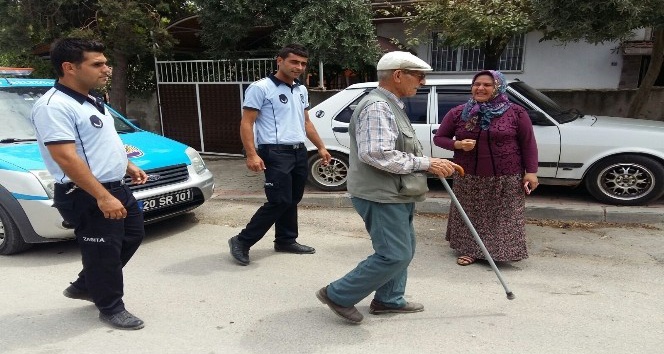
{"left": 280, "top": 0, "right": 380, "bottom": 86}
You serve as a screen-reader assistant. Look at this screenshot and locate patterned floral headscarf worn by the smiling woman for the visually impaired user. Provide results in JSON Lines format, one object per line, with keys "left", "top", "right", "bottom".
{"left": 461, "top": 70, "right": 511, "bottom": 130}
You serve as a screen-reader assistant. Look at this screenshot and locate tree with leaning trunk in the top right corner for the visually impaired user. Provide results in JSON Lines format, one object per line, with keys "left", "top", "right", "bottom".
{"left": 532, "top": 0, "right": 664, "bottom": 117}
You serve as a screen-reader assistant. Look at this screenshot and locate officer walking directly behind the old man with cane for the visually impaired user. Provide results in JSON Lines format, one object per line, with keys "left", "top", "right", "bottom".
{"left": 228, "top": 44, "right": 332, "bottom": 265}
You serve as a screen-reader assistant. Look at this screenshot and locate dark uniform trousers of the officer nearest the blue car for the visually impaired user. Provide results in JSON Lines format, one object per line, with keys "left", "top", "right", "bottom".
{"left": 53, "top": 182, "right": 145, "bottom": 315}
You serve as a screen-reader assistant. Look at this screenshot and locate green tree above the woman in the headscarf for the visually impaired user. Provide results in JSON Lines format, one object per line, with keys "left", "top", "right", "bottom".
{"left": 394, "top": 0, "right": 535, "bottom": 69}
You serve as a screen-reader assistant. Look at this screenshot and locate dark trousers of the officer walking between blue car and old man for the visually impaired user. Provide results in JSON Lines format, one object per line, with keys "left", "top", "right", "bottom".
{"left": 238, "top": 144, "right": 308, "bottom": 247}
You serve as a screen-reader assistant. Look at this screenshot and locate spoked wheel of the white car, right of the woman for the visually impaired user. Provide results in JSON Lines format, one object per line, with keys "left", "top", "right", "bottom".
{"left": 585, "top": 155, "right": 664, "bottom": 205}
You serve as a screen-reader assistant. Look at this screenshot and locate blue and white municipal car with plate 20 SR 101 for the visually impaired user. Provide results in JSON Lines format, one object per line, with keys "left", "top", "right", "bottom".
{"left": 0, "top": 78, "right": 214, "bottom": 255}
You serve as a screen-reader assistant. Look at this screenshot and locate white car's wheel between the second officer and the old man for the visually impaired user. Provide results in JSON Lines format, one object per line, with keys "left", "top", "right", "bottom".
{"left": 308, "top": 151, "right": 348, "bottom": 191}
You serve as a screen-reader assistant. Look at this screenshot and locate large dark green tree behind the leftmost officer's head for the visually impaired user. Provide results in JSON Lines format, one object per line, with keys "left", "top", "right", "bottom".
{"left": 0, "top": 0, "right": 194, "bottom": 112}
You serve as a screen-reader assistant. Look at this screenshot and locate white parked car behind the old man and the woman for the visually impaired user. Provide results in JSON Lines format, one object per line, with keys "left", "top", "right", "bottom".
{"left": 307, "top": 79, "right": 664, "bottom": 205}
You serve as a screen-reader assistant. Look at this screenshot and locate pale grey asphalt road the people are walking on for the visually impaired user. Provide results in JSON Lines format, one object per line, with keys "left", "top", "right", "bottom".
{"left": 0, "top": 197, "right": 664, "bottom": 354}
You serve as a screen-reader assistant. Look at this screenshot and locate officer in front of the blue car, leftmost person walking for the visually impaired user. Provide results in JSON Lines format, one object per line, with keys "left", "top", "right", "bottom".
{"left": 32, "top": 38, "right": 147, "bottom": 329}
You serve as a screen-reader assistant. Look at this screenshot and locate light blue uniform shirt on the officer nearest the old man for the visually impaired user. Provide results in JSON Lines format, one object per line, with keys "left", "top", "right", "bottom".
{"left": 242, "top": 74, "right": 309, "bottom": 145}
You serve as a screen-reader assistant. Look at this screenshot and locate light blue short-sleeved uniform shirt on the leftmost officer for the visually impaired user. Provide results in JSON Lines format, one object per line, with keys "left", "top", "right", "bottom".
{"left": 31, "top": 82, "right": 128, "bottom": 183}
